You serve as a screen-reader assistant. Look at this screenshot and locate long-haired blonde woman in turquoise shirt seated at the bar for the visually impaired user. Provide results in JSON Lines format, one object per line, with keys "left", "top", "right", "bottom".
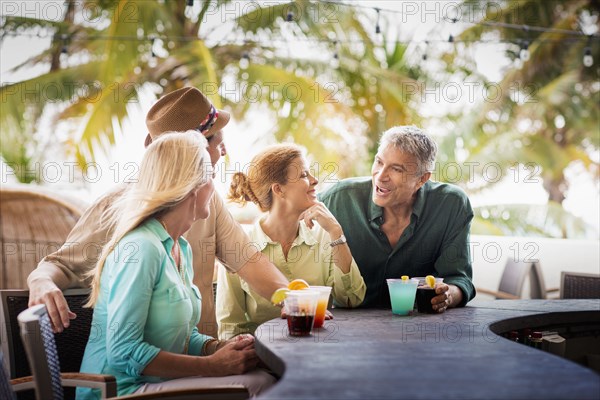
{"left": 77, "top": 131, "right": 274, "bottom": 399}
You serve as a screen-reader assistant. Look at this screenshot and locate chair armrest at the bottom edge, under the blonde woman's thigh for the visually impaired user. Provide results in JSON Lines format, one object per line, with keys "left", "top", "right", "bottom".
{"left": 119, "top": 385, "right": 250, "bottom": 400}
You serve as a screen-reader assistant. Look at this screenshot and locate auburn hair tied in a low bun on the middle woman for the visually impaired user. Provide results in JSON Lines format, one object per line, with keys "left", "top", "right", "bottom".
{"left": 227, "top": 144, "right": 304, "bottom": 212}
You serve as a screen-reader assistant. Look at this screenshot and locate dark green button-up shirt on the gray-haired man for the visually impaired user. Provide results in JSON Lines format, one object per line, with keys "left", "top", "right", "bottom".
{"left": 319, "top": 177, "right": 475, "bottom": 307}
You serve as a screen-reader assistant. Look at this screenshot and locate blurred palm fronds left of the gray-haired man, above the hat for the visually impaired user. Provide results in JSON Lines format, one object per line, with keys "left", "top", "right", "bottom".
{"left": 0, "top": 0, "right": 419, "bottom": 180}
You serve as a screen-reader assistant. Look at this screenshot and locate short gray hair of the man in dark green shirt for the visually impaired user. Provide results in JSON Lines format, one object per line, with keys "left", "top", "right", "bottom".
{"left": 378, "top": 125, "right": 437, "bottom": 175}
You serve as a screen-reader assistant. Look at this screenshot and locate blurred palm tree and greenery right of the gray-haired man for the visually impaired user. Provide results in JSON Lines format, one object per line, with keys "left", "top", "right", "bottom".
{"left": 434, "top": 0, "right": 600, "bottom": 237}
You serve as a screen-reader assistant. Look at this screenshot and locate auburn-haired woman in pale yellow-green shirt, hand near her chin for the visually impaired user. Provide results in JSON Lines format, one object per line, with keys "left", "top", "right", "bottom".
{"left": 216, "top": 144, "right": 366, "bottom": 339}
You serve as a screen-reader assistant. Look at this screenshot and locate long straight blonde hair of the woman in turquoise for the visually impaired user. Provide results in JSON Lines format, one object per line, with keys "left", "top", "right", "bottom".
{"left": 86, "top": 130, "right": 212, "bottom": 307}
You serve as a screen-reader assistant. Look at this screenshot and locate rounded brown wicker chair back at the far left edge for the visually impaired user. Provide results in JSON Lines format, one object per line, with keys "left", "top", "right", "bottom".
{"left": 0, "top": 185, "right": 85, "bottom": 289}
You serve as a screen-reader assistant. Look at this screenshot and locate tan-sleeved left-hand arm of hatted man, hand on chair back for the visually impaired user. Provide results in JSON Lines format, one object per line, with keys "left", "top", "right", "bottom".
{"left": 27, "top": 188, "right": 120, "bottom": 332}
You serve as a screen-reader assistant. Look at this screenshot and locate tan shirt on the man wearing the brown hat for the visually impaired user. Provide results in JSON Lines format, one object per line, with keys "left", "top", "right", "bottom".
{"left": 27, "top": 185, "right": 258, "bottom": 337}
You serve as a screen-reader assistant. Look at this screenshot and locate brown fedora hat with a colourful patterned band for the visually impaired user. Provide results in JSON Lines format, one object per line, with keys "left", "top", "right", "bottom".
{"left": 145, "top": 87, "right": 231, "bottom": 146}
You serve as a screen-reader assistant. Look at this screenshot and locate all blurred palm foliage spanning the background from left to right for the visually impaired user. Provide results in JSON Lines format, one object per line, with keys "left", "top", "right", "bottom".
{"left": 0, "top": 0, "right": 600, "bottom": 237}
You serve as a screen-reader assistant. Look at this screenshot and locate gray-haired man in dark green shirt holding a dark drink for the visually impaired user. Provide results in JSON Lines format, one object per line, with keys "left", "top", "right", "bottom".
{"left": 320, "top": 126, "right": 475, "bottom": 312}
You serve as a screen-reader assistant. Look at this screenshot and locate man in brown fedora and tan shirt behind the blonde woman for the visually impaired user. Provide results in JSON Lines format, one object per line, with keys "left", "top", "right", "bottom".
{"left": 27, "top": 87, "right": 288, "bottom": 336}
